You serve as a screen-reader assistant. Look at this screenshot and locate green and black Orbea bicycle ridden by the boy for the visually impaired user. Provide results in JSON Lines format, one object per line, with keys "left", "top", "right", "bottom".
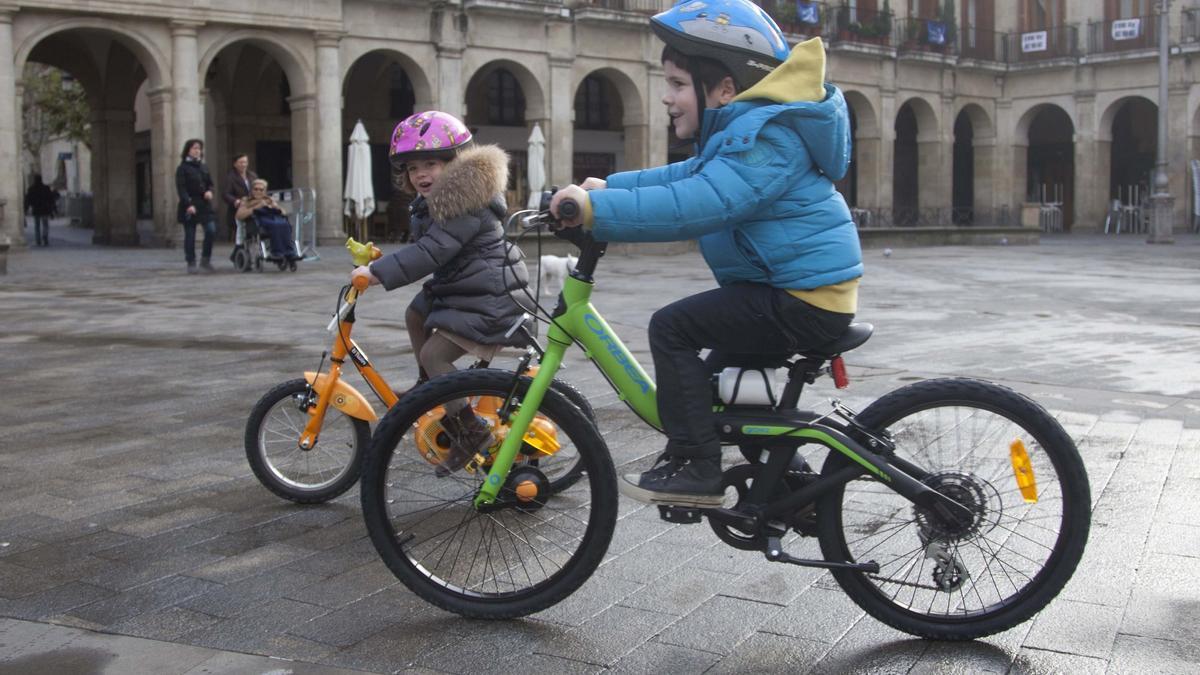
{"left": 361, "top": 193, "right": 1091, "bottom": 639}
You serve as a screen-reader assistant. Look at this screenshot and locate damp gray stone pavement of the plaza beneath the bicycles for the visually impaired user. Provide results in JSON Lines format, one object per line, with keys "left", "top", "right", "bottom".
{"left": 0, "top": 229, "right": 1200, "bottom": 673}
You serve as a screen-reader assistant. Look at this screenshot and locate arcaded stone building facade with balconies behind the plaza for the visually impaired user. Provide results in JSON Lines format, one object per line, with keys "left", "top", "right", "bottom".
{"left": 0, "top": 0, "right": 1200, "bottom": 245}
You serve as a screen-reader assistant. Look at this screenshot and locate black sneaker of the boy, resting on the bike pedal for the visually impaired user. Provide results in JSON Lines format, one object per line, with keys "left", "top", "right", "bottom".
{"left": 617, "top": 454, "right": 725, "bottom": 508}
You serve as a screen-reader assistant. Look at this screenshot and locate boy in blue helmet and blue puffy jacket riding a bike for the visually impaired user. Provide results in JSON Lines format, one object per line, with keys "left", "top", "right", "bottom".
{"left": 551, "top": 0, "right": 863, "bottom": 507}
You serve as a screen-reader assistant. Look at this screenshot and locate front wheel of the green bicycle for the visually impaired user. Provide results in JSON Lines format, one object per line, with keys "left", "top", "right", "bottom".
{"left": 361, "top": 369, "right": 617, "bottom": 619}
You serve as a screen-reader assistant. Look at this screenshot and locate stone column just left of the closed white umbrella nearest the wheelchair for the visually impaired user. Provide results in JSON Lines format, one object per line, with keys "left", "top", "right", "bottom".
{"left": 314, "top": 32, "right": 344, "bottom": 244}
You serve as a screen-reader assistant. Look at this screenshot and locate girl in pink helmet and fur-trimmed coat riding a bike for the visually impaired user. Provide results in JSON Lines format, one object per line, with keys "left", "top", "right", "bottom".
{"left": 353, "top": 110, "right": 528, "bottom": 476}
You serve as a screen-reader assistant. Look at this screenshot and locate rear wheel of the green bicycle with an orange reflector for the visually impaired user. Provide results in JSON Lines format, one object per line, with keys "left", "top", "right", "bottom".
{"left": 817, "top": 380, "right": 1091, "bottom": 640}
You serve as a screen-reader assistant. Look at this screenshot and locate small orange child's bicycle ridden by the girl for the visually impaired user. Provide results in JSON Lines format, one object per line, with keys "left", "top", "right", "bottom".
{"left": 246, "top": 239, "right": 595, "bottom": 503}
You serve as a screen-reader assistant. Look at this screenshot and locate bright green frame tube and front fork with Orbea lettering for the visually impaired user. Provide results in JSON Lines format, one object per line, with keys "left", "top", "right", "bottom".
{"left": 475, "top": 270, "right": 662, "bottom": 506}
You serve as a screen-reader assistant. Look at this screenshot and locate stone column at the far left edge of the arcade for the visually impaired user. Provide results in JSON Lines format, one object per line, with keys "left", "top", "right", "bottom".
{"left": 0, "top": 6, "right": 25, "bottom": 246}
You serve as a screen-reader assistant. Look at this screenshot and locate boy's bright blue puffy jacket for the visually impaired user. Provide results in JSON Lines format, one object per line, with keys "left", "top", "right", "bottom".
{"left": 590, "top": 48, "right": 863, "bottom": 289}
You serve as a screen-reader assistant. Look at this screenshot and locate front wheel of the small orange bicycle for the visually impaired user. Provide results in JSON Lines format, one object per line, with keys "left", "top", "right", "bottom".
{"left": 245, "top": 378, "right": 371, "bottom": 504}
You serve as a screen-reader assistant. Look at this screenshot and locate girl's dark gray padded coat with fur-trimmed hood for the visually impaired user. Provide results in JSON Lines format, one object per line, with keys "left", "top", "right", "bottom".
{"left": 371, "top": 145, "right": 529, "bottom": 346}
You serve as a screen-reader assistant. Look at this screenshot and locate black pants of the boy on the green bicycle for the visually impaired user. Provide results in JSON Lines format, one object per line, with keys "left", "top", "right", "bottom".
{"left": 649, "top": 283, "right": 854, "bottom": 458}
